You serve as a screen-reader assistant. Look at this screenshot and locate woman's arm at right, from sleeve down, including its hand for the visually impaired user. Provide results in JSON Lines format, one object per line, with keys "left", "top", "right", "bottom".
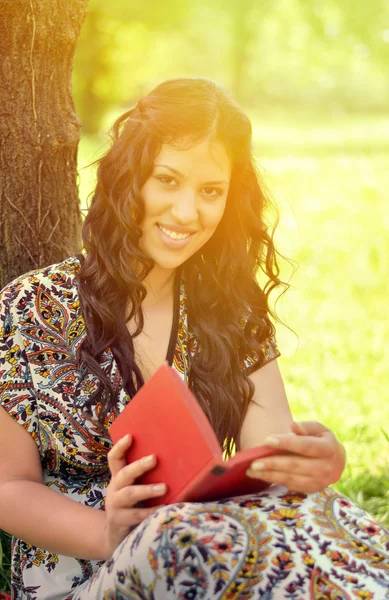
{"left": 239, "top": 360, "right": 346, "bottom": 493}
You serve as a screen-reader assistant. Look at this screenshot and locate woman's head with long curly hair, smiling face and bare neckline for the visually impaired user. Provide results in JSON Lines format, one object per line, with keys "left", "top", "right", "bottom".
{"left": 80, "top": 78, "right": 282, "bottom": 440}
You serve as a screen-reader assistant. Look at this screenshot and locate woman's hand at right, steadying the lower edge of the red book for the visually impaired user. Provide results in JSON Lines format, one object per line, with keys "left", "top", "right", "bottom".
{"left": 246, "top": 421, "right": 346, "bottom": 494}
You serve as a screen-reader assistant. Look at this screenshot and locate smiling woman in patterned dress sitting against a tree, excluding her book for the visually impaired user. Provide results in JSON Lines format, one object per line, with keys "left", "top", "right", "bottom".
{"left": 0, "top": 79, "right": 389, "bottom": 600}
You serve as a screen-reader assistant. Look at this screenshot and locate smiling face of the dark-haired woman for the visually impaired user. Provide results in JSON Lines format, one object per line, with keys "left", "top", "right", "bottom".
{"left": 140, "top": 140, "right": 231, "bottom": 269}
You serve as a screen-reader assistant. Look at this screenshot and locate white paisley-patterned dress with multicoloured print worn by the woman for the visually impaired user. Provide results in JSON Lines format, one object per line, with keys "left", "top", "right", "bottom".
{"left": 0, "top": 257, "right": 389, "bottom": 600}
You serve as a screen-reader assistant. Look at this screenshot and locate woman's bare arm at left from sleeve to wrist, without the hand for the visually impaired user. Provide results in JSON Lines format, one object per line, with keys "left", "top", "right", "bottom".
{"left": 0, "top": 407, "right": 106, "bottom": 560}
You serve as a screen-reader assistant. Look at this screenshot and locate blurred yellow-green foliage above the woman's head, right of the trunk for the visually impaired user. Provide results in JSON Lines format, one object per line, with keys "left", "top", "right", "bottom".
{"left": 74, "top": 0, "right": 389, "bottom": 133}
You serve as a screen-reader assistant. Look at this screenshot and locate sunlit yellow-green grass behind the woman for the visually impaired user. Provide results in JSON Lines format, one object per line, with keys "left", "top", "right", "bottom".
{"left": 0, "top": 113, "right": 389, "bottom": 590}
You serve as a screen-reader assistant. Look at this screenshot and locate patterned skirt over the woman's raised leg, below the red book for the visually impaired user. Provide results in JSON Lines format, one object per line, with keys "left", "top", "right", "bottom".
{"left": 69, "top": 486, "right": 389, "bottom": 600}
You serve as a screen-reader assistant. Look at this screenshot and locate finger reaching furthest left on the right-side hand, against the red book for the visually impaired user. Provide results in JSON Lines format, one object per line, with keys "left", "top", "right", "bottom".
{"left": 250, "top": 454, "right": 325, "bottom": 479}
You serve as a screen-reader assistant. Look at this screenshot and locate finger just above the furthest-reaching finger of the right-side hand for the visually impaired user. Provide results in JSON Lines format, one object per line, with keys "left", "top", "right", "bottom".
{"left": 264, "top": 434, "right": 333, "bottom": 458}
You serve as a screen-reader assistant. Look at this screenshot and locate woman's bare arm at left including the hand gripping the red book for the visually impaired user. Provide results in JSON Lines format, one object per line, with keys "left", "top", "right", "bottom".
{"left": 0, "top": 407, "right": 166, "bottom": 560}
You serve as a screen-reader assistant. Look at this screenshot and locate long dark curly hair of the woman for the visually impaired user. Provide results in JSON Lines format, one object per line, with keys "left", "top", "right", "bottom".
{"left": 79, "top": 78, "right": 290, "bottom": 456}
